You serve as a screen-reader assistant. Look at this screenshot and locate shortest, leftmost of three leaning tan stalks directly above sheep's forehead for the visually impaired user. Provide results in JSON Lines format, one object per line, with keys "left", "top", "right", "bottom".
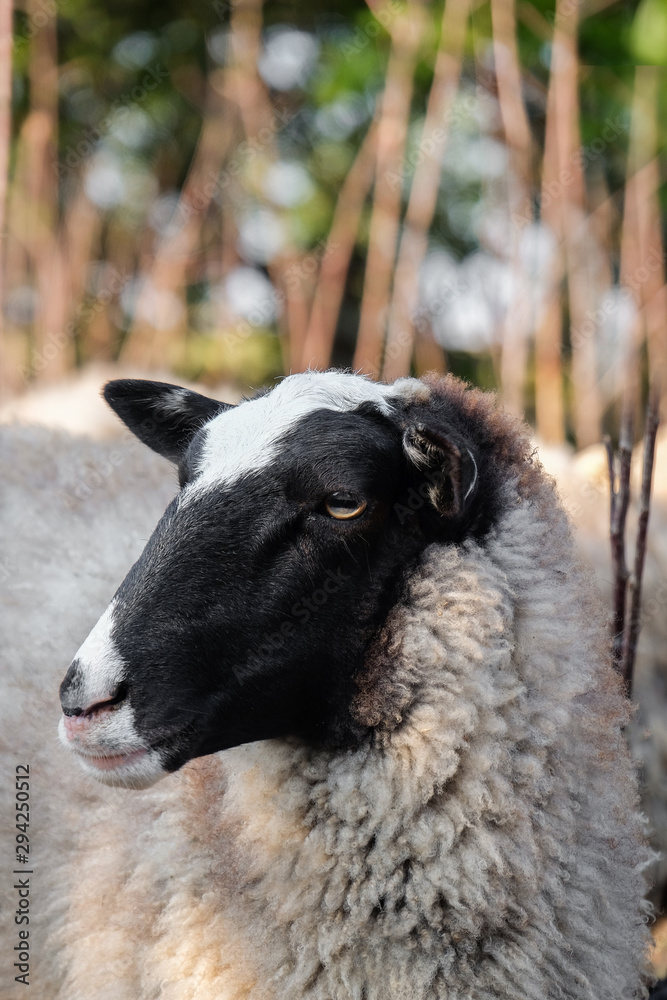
{"left": 301, "top": 122, "right": 377, "bottom": 368}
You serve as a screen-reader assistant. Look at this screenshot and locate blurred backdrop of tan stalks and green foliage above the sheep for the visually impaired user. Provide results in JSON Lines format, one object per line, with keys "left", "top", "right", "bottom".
{"left": 0, "top": 0, "right": 667, "bottom": 448}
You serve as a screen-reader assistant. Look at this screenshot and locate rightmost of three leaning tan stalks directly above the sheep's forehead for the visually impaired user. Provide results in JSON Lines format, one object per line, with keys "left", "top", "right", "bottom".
{"left": 382, "top": 0, "right": 470, "bottom": 381}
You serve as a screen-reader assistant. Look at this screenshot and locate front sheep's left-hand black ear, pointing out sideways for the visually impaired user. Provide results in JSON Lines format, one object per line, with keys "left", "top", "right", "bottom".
{"left": 103, "top": 378, "right": 231, "bottom": 464}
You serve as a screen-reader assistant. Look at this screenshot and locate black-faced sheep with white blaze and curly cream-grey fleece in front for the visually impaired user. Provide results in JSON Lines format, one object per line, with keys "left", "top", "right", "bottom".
{"left": 0, "top": 372, "right": 649, "bottom": 1000}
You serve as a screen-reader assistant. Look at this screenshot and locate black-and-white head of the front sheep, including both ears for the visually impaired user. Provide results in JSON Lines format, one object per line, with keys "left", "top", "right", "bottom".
{"left": 60, "top": 372, "right": 496, "bottom": 787}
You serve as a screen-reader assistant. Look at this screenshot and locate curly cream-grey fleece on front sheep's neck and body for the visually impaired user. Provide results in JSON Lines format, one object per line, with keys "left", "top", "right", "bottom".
{"left": 0, "top": 378, "right": 648, "bottom": 1000}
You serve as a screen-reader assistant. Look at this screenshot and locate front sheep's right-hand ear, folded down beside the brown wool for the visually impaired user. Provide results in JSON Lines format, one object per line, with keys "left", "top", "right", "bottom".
{"left": 403, "top": 424, "right": 478, "bottom": 517}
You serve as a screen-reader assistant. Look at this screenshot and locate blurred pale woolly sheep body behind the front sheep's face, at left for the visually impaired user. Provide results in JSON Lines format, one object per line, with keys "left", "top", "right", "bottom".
{"left": 0, "top": 426, "right": 176, "bottom": 1000}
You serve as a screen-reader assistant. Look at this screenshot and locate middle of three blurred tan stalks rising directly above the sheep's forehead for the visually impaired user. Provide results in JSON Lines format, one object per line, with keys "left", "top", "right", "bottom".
{"left": 353, "top": 3, "right": 426, "bottom": 377}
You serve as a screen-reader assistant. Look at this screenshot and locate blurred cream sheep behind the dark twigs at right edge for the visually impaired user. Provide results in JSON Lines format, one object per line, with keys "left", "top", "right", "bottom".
{"left": 539, "top": 430, "right": 667, "bottom": 910}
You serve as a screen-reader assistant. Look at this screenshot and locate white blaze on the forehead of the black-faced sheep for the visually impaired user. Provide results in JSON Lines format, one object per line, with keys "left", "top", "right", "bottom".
{"left": 183, "top": 372, "right": 423, "bottom": 500}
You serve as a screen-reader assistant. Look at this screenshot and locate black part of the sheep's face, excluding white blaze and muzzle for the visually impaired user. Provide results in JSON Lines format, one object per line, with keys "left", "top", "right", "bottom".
{"left": 61, "top": 382, "right": 496, "bottom": 770}
